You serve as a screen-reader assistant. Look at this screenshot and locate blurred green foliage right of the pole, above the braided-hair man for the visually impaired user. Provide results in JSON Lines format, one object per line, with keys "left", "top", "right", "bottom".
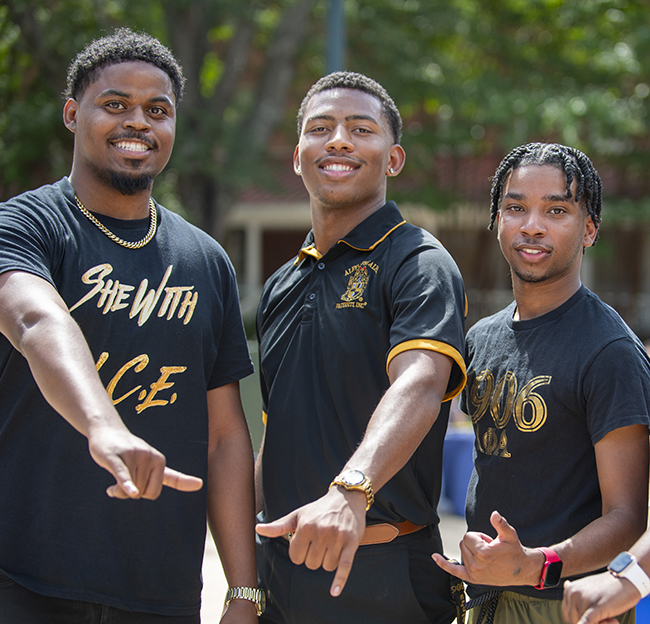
{"left": 340, "top": 0, "right": 650, "bottom": 210}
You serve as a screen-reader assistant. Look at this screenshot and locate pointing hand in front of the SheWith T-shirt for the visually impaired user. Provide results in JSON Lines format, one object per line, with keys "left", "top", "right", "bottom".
{"left": 88, "top": 423, "right": 203, "bottom": 500}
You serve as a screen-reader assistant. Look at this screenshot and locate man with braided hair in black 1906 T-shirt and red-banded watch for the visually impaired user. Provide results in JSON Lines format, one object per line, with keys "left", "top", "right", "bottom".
{"left": 434, "top": 143, "right": 650, "bottom": 624}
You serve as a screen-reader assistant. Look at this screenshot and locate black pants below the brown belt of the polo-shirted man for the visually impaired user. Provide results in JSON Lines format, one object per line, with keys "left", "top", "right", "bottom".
{"left": 257, "top": 527, "right": 456, "bottom": 624}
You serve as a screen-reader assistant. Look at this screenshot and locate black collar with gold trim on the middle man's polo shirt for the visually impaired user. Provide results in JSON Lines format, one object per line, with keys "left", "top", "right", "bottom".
{"left": 294, "top": 201, "right": 406, "bottom": 264}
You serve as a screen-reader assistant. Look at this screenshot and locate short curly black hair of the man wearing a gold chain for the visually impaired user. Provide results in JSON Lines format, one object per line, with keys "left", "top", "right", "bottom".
{"left": 63, "top": 28, "right": 185, "bottom": 105}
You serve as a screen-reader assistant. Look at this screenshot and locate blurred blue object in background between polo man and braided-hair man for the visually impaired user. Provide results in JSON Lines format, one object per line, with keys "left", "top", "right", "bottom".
{"left": 442, "top": 428, "right": 474, "bottom": 516}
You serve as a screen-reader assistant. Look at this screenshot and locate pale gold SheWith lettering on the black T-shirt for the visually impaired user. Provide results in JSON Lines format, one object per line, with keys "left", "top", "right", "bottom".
{"left": 70, "top": 264, "right": 199, "bottom": 326}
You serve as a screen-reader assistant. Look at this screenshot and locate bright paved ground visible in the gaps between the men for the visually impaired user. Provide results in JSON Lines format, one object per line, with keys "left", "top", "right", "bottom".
{"left": 201, "top": 514, "right": 466, "bottom": 624}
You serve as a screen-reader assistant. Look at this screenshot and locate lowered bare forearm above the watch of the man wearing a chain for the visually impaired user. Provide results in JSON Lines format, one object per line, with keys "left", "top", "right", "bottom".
{"left": 208, "top": 427, "right": 257, "bottom": 587}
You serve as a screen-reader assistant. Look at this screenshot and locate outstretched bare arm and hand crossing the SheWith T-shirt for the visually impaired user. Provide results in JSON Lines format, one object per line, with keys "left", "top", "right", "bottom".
{"left": 0, "top": 271, "right": 195, "bottom": 499}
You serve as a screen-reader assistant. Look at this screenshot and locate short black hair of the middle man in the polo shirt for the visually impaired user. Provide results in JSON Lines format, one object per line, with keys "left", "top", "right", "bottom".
{"left": 297, "top": 71, "right": 402, "bottom": 143}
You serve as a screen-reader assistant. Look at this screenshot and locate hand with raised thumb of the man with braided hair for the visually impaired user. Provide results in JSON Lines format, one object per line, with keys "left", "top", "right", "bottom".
{"left": 432, "top": 511, "right": 544, "bottom": 587}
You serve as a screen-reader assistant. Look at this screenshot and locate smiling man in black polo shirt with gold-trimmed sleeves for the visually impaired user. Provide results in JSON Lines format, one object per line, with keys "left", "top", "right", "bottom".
{"left": 256, "top": 72, "right": 465, "bottom": 624}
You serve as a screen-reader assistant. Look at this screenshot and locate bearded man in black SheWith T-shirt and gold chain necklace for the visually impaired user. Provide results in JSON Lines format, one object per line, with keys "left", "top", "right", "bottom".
{"left": 0, "top": 29, "right": 257, "bottom": 624}
